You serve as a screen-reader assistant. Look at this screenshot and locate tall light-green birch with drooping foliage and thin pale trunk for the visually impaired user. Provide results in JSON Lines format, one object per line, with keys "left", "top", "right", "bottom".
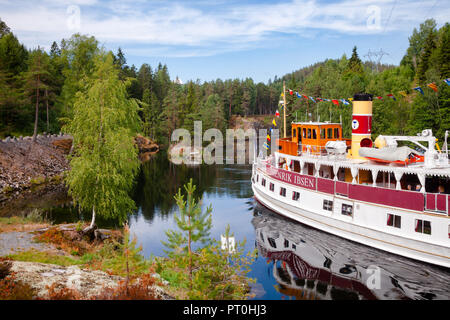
{"left": 66, "top": 53, "right": 140, "bottom": 232}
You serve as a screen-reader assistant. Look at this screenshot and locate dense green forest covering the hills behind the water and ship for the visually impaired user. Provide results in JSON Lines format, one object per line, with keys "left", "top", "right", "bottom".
{"left": 0, "top": 19, "right": 450, "bottom": 144}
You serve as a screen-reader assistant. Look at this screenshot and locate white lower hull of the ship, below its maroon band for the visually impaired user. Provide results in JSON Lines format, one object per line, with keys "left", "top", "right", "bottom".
{"left": 252, "top": 168, "right": 450, "bottom": 268}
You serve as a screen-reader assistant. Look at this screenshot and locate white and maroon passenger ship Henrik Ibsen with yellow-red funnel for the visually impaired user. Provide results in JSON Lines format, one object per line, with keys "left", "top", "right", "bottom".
{"left": 252, "top": 93, "right": 450, "bottom": 268}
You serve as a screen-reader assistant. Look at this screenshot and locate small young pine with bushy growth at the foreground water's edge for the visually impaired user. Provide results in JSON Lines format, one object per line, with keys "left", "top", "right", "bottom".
{"left": 157, "top": 179, "right": 256, "bottom": 300}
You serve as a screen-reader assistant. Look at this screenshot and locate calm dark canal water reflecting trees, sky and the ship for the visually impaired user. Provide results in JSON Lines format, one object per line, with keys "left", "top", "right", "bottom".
{"left": 7, "top": 152, "right": 450, "bottom": 300}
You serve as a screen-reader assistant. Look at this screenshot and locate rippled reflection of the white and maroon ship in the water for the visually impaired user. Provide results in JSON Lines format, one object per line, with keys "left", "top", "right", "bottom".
{"left": 252, "top": 204, "right": 450, "bottom": 300}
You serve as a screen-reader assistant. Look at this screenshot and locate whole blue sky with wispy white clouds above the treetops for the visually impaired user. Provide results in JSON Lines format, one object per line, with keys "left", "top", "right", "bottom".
{"left": 0, "top": 0, "right": 450, "bottom": 82}
